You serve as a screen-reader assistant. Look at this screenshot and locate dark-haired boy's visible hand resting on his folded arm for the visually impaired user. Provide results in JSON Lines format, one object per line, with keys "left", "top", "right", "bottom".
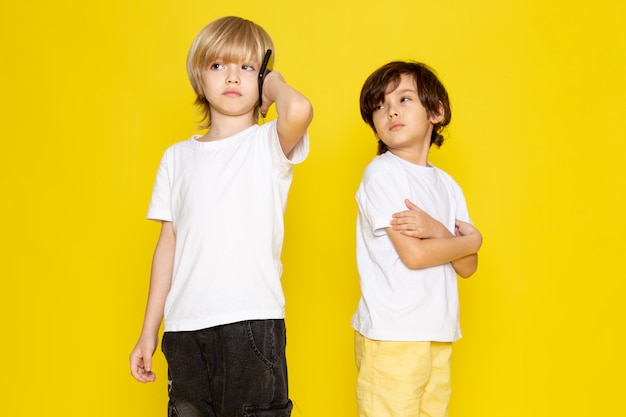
{"left": 390, "top": 200, "right": 452, "bottom": 239}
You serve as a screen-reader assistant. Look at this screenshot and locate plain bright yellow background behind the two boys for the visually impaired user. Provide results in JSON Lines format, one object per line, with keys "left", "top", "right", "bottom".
{"left": 0, "top": 0, "right": 626, "bottom": 417}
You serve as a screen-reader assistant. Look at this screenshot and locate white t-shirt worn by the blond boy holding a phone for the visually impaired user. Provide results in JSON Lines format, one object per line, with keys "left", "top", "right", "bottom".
{"left": 148, "top": 121, "right": 309, "bottom": 331}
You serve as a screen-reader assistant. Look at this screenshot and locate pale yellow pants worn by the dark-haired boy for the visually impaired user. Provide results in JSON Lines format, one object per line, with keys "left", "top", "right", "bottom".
{"left": 354, "top": 332, "right": 452, "bottom": 417}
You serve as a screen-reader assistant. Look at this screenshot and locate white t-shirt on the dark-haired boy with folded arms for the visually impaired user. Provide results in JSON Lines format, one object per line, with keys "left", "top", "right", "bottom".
{"left": 352, "top": 152, "right": 470, "bottom": 342}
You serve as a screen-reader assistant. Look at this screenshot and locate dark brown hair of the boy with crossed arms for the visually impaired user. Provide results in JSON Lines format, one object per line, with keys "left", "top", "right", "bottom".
{"left": 360, "top": 61, "right": 452, "bottom": 155}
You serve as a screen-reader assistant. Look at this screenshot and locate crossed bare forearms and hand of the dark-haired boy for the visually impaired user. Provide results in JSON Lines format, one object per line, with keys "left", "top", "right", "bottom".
{"left": 386, "top": 200, "right": 482, "bottom": 278}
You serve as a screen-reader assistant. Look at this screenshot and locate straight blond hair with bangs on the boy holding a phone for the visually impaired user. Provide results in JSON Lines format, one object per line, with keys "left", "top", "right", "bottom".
{"left": 187, "top": 16, "right": 274, "bottom": 128}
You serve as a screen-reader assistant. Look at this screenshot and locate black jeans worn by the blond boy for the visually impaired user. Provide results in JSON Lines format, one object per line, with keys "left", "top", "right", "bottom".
{"left": 161, "top": 320, "right": 292, "bottom": 417}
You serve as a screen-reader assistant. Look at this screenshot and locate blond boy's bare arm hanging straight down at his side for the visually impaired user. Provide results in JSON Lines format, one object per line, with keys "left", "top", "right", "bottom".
{"left": 130, "top": 221, "right": 176, "bottom": 383}
